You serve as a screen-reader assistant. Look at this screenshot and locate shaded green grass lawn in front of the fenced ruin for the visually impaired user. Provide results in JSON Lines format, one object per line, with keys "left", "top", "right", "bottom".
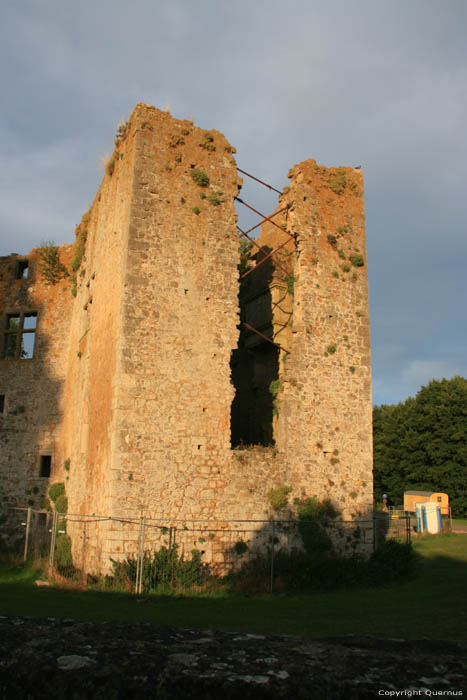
{"left": 0, "top": 535, "right": 467, "bottom": 639}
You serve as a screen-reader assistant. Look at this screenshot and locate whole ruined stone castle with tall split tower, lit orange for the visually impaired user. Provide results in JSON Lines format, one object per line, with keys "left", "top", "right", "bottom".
{"left": 0, "top": 104, "right": 373, "bottom": 567}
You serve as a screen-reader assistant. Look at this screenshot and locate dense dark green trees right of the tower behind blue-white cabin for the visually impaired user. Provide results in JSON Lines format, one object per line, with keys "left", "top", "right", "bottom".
{"left": 373, "top": 377, "right": 467, "bottom": 517}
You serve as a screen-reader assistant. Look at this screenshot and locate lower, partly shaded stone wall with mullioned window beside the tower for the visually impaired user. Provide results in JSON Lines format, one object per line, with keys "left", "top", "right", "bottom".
{"left": 0, "top": 246, "right": 72, "bottom": 520}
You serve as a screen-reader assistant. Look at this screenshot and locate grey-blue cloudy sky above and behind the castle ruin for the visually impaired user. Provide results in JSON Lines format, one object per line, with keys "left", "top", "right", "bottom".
{"left": 0, "top": 0, "right": 467, "bottom": 404}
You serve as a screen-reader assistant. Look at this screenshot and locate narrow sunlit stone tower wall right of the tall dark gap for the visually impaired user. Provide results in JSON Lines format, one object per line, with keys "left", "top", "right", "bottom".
{"left": 278, "top": 160, "right": 373, "bottom": 518}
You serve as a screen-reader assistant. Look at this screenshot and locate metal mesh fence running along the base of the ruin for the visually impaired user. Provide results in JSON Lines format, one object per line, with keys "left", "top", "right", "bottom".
{"left": 5, "top": 508, "right": 410, "bottom": 593}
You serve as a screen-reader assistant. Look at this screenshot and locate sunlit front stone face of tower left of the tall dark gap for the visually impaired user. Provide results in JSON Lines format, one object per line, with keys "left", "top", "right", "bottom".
{"left": 113, "top": 106, "right": 239, "bottom": 528}
